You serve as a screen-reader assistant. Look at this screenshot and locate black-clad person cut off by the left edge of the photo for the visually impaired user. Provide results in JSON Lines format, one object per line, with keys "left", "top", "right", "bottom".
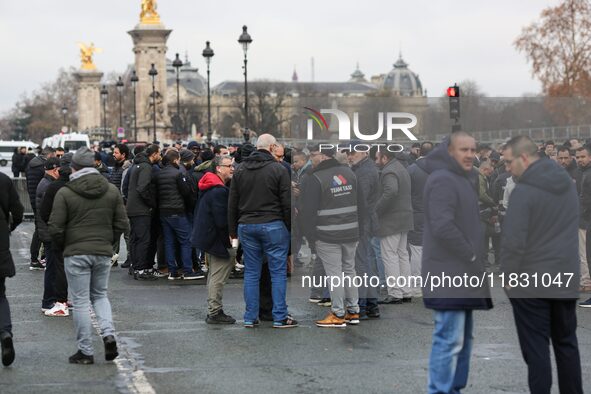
{"left": 0, "top": 173, "right": 24, "bottom": 366}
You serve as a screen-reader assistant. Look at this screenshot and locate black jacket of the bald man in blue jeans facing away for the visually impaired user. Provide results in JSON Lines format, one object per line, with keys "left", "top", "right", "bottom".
{"left": 228, "top": 149, "right": 291, "bottom": 236}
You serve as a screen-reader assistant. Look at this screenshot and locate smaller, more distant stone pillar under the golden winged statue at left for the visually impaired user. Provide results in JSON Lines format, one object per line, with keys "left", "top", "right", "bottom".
{"left": 74, "top": 70, "right": 103, "bottom": 131}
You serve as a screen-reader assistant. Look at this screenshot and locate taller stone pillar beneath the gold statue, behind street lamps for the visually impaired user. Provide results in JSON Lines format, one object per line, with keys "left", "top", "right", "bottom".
{"left": 128, "top": 23, "right": 172, "bottom": 142}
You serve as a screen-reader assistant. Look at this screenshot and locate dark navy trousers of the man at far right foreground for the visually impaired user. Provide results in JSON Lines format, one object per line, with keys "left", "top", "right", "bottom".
{"left": 511, "top": 298, "right": 583, "bottom": 394}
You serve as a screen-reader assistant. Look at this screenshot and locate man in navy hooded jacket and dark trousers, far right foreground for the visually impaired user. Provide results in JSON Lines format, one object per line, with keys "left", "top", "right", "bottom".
{"left": 501, "top": 136, "right": 583, "bottom": 393}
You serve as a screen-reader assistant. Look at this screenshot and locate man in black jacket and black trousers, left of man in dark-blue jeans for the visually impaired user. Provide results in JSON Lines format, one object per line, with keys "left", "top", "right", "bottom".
{"left": 127, "top": 144, "right": 160, "bottom": 280}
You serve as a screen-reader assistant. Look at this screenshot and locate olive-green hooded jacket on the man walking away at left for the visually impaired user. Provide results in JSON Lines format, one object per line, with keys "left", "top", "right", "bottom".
{"left": 49, "top": 168, "right": 129, "bottom": 257}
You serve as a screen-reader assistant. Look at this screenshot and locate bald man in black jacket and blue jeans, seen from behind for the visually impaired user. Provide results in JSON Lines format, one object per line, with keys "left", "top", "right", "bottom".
{"left": 228, "top": 134, "right": 298, "bottom": 328}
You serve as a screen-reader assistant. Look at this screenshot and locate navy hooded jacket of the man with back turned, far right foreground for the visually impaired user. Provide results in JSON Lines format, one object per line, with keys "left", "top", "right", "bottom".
{"left": 501, "top": 159, "right": 580, "bottom": 299}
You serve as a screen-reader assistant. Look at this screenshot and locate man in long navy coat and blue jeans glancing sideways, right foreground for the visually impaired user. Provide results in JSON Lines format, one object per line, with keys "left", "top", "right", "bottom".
{"left": 422, "top": 132, "right": 492, "bottom": 393}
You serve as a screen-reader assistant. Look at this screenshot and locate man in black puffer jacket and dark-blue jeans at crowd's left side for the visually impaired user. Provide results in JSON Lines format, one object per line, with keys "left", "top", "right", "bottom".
{"left": 154, "top": 149, "right": 205, "bottom": 280}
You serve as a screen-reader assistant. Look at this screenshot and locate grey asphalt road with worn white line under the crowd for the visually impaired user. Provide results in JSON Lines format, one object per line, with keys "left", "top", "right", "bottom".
{"left": 0, "top": 223, "right": 591, "bottom": 394}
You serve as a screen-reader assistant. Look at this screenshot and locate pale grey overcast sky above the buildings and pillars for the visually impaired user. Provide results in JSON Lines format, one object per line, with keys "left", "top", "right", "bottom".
{"left": 0, "top": 0, "right": 558, "bottom": 113}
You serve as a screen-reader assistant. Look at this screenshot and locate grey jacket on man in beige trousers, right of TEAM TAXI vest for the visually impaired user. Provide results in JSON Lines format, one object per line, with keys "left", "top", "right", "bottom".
{"left": 376, "top": 159, "right": 413, "bottom": 237}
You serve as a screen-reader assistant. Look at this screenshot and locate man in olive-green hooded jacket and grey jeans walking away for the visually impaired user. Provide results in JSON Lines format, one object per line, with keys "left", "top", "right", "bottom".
{"left": 48, "top": 147, "right": 129, "bottom": 364}
